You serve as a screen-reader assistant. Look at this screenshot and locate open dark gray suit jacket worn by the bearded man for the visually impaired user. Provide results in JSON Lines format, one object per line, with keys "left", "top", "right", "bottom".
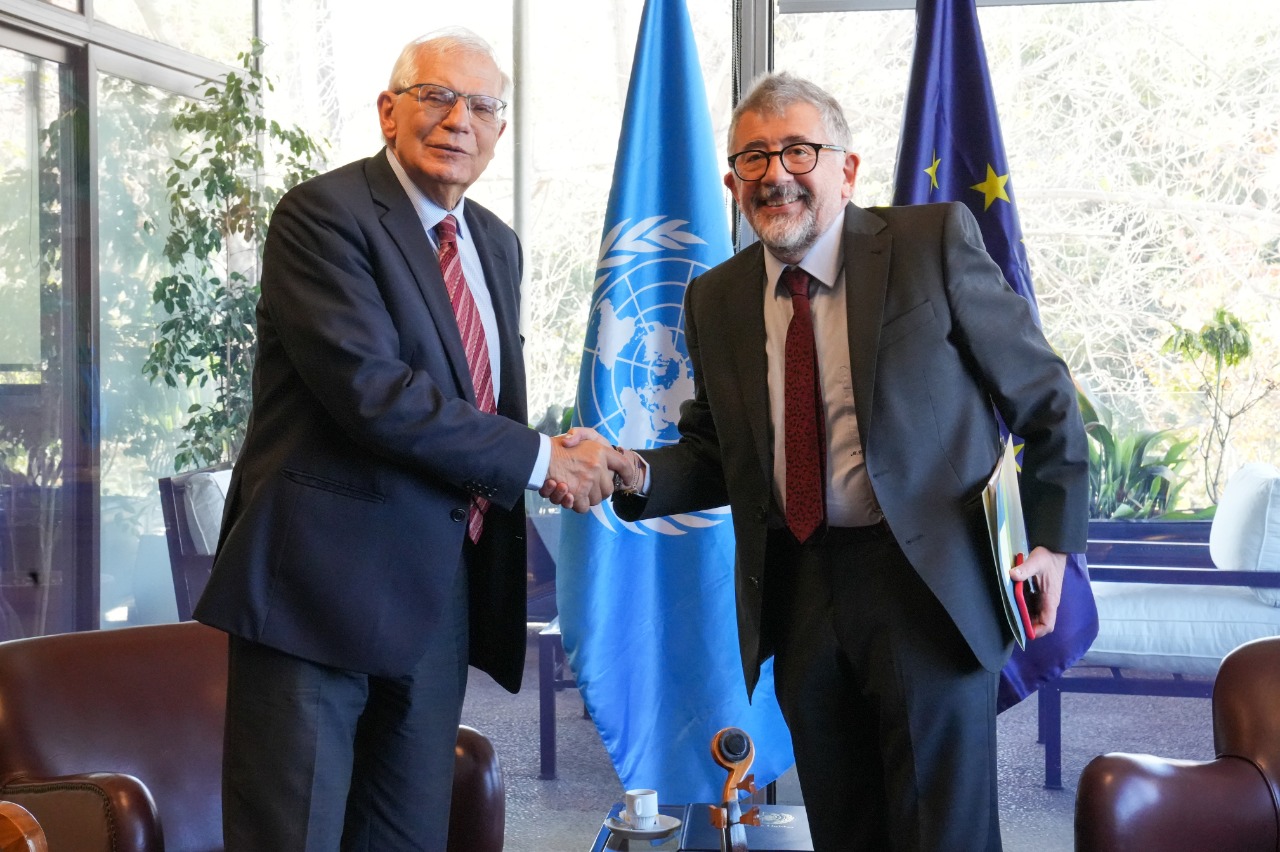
{"left": 614, "top": 203, "right": 1088, "bottom": 690}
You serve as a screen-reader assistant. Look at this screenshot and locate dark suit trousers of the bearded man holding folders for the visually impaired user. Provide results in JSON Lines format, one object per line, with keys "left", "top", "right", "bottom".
{"left": 764, "top": 523, "right": 1001, "bottom": 852}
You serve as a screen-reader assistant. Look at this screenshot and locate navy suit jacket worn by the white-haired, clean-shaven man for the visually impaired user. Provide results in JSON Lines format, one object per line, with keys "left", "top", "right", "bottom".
{"left": 195, "top": 151, "right": 539, "bottom": 691}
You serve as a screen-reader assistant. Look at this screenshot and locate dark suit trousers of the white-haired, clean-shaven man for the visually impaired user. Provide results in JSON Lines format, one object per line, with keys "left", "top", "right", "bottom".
{"left": 223, "top": 548, "right": 470, "bottom": 852}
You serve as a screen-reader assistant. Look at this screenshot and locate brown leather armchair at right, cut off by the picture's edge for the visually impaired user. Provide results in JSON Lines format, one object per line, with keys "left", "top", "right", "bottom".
{"left": 1075, "top": 637, "right": 1280, "bottom": 852}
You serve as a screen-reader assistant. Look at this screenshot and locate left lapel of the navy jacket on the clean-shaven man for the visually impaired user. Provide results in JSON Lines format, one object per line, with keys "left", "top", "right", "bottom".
{"left": 366, "top": 150, "right": 488, "bottom": 404}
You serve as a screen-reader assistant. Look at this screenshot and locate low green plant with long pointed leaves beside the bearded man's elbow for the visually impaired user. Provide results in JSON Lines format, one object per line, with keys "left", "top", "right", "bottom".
{"left": 1076, "top": 388, "right": 1193, "bottom": 521}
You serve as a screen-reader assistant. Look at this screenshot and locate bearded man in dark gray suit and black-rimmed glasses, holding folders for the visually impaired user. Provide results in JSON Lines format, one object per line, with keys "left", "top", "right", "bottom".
{"left": 547, "top": 74, "right": 1088, "bottom": 852}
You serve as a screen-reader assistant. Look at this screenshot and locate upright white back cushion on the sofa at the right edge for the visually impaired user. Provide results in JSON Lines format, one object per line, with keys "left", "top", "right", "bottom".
{"left": 1208, "top": 462, "right": 1280, "bottom": 606}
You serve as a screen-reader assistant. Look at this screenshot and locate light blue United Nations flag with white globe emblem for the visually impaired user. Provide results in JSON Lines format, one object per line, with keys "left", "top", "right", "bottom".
{"left": 556, "top": 0, "right": 794, "bottom": 802}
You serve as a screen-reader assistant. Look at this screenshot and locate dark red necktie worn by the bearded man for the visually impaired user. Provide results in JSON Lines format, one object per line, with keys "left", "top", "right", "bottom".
{"left": 780, "top": 266, "right": 827, "bottom": 542}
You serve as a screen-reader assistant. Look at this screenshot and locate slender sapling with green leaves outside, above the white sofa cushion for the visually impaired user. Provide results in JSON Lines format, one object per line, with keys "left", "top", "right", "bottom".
{"left": 1164, "top": 307, "right": 1276, "bottom": 503}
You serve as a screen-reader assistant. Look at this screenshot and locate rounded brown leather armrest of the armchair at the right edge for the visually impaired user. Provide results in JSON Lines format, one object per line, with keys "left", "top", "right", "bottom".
{"left": 1075, "top": 753, "right": 1277, "bottom": 852}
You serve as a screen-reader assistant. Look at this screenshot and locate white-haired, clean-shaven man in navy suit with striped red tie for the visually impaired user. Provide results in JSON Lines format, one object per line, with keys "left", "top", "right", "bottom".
{"left": 196, "top": 31, "right": 621, "bottom": 852}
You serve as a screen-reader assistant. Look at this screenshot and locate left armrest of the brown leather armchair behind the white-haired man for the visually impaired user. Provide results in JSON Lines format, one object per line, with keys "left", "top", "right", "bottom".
{"left": 0, "top": 773, "right": 163, "bottom": 852}
